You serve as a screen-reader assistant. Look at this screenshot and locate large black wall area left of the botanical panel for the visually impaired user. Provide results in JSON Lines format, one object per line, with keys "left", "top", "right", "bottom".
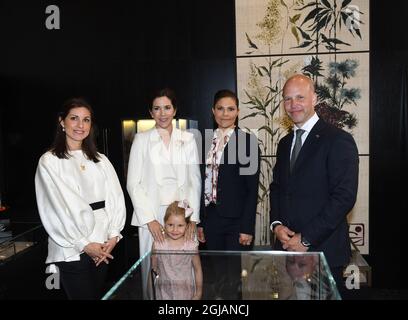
{"left": 0, "top": 0, "right": 235, "bottom": 219}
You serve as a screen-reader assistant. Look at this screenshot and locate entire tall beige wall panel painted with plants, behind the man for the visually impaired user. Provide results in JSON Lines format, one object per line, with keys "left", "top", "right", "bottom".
{"left": 235, "top": 0, "right": 369, "bottom": 253}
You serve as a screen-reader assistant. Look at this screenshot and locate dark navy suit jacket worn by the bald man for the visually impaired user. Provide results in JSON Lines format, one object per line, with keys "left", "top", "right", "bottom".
{"left": 270, "top": 119, "right": 359, "bottom": 267}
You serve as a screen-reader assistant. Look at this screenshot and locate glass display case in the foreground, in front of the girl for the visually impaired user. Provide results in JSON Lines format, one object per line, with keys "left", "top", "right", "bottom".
{"left": 103, "top": 251, "right": 341, "bottom": 300}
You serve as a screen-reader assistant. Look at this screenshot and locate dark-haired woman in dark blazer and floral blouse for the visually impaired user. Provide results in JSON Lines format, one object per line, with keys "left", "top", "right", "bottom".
{"left": 198, "top": 90, "right": 259, "bottom": 250}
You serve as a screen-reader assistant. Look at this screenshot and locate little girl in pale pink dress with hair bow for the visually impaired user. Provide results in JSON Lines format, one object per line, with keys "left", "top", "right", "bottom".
{"left": 152, "top": 200, "right": 203, "bottom": 300}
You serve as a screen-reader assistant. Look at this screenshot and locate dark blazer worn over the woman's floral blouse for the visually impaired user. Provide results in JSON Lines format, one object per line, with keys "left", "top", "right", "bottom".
{"left": 200, "top": 128, "right": 260, "bottom": 235}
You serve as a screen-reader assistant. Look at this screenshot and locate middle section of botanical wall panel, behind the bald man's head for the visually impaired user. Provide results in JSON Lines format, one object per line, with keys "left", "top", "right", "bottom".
{"left": 237, "top": 53, "right": 369, "bottom": 155}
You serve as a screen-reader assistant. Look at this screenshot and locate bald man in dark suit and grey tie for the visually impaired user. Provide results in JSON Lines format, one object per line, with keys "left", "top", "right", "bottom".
{"left": 270, "top": 75, "right": 359, "bottom": 290}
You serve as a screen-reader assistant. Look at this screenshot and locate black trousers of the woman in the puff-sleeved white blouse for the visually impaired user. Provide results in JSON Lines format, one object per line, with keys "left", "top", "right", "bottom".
{"left": 55, "top": 253, "right": 108, "bottom": 300}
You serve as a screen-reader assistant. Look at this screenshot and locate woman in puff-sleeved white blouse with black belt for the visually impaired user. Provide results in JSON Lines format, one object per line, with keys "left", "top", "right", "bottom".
{"left": 35, "top": 99, "right": 126, "bottom": 299}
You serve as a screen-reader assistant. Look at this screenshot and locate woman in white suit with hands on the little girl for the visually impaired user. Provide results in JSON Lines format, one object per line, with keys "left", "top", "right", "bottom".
{"left": 127, "top": 88, "right": 201, "bottom": 297}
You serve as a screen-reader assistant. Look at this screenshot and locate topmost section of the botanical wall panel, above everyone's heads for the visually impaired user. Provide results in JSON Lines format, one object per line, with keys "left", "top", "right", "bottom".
{"left": 235, "top": 0, "right": 369, "bottom": 56}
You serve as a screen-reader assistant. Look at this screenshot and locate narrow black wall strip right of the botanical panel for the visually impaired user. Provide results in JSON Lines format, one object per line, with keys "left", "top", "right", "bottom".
{"left": 369, "top": 1, "right": 408, "bottom": 288}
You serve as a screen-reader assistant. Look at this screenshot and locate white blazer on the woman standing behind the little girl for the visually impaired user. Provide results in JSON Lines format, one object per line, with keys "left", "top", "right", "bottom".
{"left": 127, "top": 127, "right": 201, "bottom": 227}
